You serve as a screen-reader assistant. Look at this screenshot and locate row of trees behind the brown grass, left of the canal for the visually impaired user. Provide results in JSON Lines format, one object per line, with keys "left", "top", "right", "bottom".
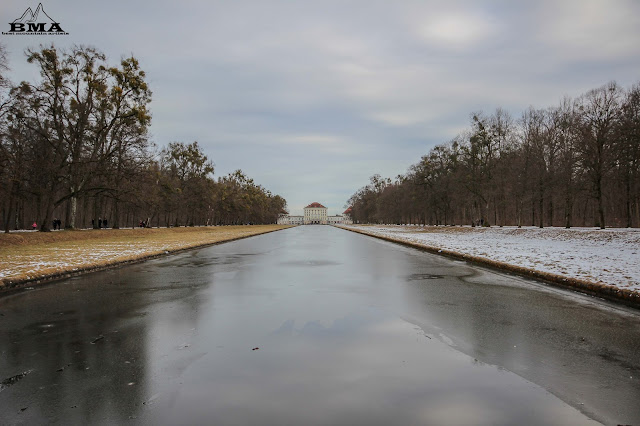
{"left": 0, "top": 45, "right": 286, "bottom": 232}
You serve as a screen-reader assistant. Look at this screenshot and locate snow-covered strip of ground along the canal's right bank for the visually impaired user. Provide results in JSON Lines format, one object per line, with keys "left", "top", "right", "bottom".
{"left": 346, "top": 225, "right": 640, "bottom": 291}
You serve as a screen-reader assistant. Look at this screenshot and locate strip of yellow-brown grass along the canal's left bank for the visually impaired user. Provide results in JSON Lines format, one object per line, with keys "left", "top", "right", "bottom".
{"left": 0, "top": 225, "right": 287, "bottom": 290}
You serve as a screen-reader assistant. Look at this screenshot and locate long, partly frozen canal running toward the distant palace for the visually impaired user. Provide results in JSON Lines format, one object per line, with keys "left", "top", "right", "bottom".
{"left": 0, "top": 226, "right": 640, "bottom": 425}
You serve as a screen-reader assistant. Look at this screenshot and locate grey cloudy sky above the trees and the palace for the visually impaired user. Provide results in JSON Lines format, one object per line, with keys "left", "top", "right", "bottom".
{"left": 0, "top": 0, "right": 640, "bottom": 214}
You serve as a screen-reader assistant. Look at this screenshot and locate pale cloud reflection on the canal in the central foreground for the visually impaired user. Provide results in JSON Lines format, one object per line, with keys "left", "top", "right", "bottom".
{"left": 146, "top": 308, "right": 587, "bottom": 424}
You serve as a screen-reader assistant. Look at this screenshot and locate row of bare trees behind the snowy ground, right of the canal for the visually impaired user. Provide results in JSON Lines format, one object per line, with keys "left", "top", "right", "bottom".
{"left": 348, "top": 83, "right": 640, "bottom": 228}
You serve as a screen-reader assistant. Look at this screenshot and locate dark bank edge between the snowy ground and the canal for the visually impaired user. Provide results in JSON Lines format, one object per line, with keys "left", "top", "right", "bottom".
{"left": 337, "top": 226, "right": 640, "bottom": 309}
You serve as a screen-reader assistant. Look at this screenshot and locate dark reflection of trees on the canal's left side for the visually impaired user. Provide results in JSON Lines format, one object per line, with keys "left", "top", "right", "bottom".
{"left": 0, "top": 265, "right": 201, "bottom": 423}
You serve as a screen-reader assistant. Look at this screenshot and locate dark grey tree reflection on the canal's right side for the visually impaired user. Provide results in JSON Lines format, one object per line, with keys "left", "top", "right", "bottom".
{"left": 405, "top": 263, "right": 640, "bottom": 422}
